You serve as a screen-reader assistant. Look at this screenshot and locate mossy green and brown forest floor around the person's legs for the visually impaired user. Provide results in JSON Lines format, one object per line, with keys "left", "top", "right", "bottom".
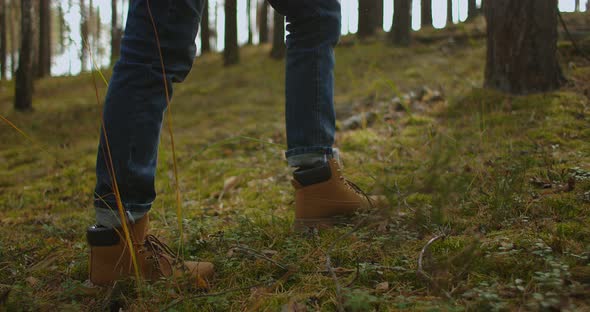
{"left": 0, "top": 14, "right": 590, "bottom": 311}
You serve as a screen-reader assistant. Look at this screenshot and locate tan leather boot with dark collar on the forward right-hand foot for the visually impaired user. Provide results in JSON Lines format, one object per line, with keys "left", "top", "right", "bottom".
{"left": 292, "top": 158, "right": 374, "bottom": 230}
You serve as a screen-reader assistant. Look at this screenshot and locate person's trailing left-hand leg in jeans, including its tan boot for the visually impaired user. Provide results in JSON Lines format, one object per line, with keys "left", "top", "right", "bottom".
{"left": 86, "top": 0, "right": 214, "bottom": 287}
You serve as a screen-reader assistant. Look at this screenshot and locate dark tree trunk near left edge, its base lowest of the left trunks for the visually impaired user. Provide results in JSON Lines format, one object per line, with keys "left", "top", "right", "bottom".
{"left": 14, "top": 0, "right": 35, "bottom": 111}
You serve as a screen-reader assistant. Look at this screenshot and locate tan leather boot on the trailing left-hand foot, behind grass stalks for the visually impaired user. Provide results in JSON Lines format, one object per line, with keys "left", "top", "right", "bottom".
{"left": 86, "top": 215, "right": 214, "bottom": 288}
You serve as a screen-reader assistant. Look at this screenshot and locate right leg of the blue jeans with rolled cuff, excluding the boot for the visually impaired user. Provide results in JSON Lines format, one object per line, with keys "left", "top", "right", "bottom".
{"left": 270, "top": 0, "right": 341, "bottom": 167}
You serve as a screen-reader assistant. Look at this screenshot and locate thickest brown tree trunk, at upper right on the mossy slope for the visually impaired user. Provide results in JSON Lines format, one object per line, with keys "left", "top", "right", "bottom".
{"left": 485, "top": 0, "right": 565, "bottom": 94}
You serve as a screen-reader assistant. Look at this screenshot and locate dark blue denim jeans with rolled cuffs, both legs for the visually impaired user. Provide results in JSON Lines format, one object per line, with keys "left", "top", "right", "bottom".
{"left": 94, "top": 0, "right": 340, "bottom": 226}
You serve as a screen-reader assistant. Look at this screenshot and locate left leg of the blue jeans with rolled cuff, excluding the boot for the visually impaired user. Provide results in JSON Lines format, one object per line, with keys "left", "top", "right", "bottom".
{"left": 94, "top": 0, "right": 204, "bottom": 227}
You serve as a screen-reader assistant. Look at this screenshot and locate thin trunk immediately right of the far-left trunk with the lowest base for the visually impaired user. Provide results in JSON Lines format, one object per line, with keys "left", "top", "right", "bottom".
{"left": 37, "top": 0, "right": 52, "bottom": 78}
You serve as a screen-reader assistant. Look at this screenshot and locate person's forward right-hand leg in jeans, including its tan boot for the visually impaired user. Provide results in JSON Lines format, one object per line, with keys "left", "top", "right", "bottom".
{"left": 270, "top": 0, "right": 373, "bottom": 229}
